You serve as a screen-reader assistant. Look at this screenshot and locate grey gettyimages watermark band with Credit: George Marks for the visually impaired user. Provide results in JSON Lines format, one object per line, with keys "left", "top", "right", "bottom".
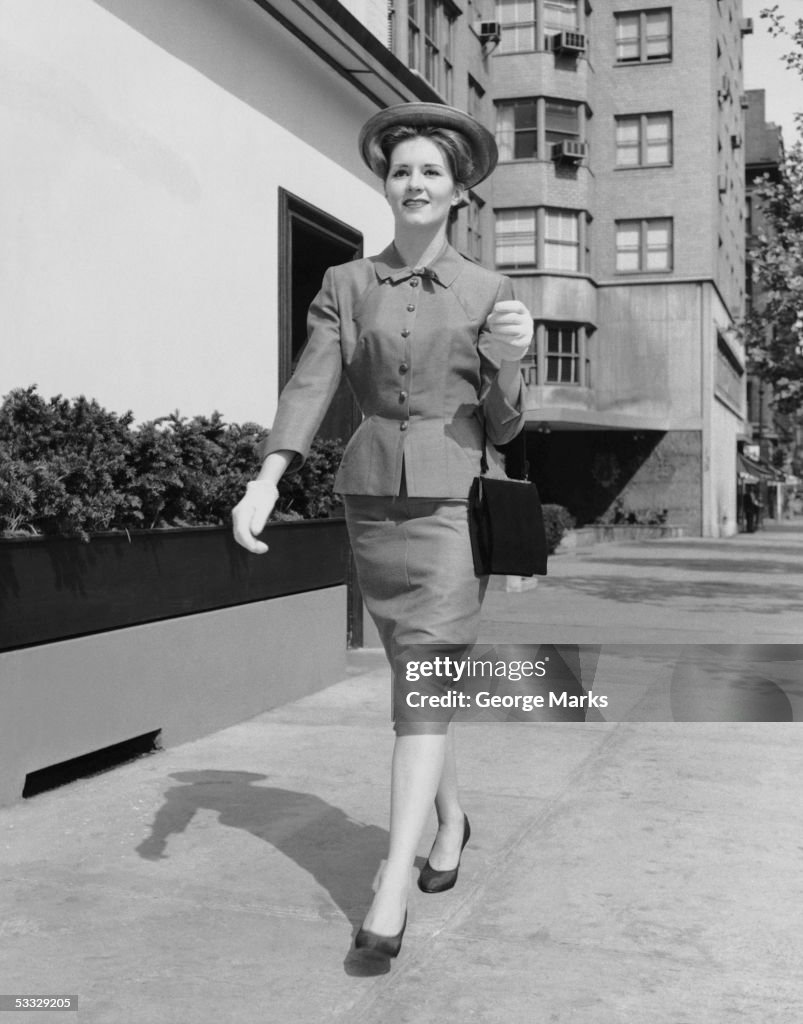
{"left": 393, "top": 644, "right": 803, "bottom": 723}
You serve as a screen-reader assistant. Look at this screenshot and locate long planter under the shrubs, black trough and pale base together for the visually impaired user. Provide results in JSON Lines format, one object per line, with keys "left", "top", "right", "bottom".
{"left": 0, "top": 520, "right": 348, "bottom": 806}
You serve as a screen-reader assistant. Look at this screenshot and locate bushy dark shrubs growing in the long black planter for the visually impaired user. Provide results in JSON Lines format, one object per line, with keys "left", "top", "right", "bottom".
{"left": 0, "top": 386, "right": 342, "bottom": 540}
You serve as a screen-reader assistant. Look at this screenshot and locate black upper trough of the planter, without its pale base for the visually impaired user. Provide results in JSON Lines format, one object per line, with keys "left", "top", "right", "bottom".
{"left": 0, "top": 519, "right": 348, "bottom": 650}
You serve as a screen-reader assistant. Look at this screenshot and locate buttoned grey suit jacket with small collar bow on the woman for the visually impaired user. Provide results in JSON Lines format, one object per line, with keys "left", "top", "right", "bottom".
{"left": 261, "top": 239, "right": 524, "bottom": 498}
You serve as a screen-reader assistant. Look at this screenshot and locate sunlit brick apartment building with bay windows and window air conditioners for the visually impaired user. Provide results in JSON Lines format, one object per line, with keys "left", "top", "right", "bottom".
{"left": 492, "top": 0, "right": 751, "bottom": 536}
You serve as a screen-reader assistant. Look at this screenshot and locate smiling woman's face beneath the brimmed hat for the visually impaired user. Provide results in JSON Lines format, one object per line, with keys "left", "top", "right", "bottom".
{"left": 385, "top": 136, "right": 461, "bottom": 227}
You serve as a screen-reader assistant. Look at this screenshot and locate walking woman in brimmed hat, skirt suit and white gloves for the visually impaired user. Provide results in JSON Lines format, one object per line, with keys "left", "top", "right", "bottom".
{"left": 233, "top": 103, "right": 533, "bottom": 956}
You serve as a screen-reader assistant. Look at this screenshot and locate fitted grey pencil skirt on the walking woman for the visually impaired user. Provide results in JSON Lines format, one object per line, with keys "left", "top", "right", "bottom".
{"left": 344, "top": 493, "right": 488, "bottom": 735}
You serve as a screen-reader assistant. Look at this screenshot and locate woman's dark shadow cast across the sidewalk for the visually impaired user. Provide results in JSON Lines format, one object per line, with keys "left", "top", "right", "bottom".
{"left": 136, "top": 770, "right": 405, "bottom": 976}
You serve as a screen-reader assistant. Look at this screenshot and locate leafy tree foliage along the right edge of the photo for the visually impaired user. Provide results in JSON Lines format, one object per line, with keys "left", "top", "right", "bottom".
{"left": 743, "top": 4, "right": 803, "bottom": 413}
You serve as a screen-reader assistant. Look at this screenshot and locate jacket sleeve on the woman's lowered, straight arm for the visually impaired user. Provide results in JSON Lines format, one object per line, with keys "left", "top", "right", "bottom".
{"left": 259, "top": 267, "right": 343, "bottom": 473}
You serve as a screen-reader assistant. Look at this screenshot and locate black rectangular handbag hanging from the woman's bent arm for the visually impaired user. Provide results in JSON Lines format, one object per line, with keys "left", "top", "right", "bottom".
{"left": 468, "top": 430, "right": 547, "bottom": 577}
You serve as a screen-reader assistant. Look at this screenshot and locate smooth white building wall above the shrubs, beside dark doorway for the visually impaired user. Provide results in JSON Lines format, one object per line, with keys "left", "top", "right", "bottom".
{"left": 0, "top": 0, "right": 392, "bottom": 424}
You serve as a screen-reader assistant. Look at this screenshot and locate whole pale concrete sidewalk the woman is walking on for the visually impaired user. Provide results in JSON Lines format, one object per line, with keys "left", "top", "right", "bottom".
{"left": 0, "top": 529, "right": 803, "bottom": 1024}
